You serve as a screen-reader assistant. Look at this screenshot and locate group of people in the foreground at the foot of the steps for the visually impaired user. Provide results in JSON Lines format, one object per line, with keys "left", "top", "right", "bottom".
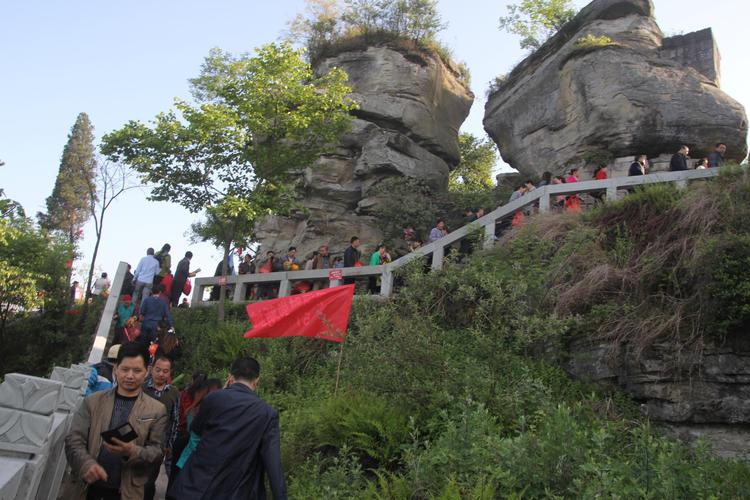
{"left": 65, "top": 342, "right": 286, "bottom": 500}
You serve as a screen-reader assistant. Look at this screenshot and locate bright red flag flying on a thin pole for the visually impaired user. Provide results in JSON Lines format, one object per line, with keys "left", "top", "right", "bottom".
{"left": 245, "top": 285, "right": 354, "bottom": 342}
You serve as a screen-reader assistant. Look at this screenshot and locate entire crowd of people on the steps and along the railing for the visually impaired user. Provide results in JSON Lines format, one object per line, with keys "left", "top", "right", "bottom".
{"left": 57, "top": 143, "right": 726, "bottom": 500}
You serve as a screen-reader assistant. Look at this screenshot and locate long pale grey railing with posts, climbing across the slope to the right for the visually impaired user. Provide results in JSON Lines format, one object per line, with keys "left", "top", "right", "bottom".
{"left": 192, "top": 168, "right": 720, "bottom": 306}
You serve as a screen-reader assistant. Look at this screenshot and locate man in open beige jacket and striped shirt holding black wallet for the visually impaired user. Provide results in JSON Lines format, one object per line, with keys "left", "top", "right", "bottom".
{"left": 65, "top": 343, "right": 169, "bottom": 500}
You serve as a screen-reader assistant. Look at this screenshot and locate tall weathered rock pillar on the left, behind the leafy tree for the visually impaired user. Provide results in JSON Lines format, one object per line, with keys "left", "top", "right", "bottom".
{"left": 258, "top": 46, "right": 474, "bottom": 256}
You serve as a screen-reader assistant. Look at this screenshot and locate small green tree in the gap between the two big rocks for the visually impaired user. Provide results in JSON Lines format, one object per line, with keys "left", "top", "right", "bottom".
{"left": 448, "top": 132, "right": 497, "bottom": 192}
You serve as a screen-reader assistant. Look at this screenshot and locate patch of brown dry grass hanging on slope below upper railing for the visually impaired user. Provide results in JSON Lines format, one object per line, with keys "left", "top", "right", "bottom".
{"left": 509, "top": 173, "right": 750, "bottom": 359}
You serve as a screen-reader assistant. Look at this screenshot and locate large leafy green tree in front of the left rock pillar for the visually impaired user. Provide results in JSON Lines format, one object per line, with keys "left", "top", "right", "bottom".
{"left": 102, "top": 44, "right": 355, "bottom": 320}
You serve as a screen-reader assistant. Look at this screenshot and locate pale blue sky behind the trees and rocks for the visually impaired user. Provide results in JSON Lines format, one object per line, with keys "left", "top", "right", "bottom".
{"left": 0, "top": 0, "right": 750, "bottom": 292}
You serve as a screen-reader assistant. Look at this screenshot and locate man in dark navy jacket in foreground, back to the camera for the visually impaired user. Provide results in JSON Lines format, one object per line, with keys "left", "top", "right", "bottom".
{"left": 167, "top": 358, "right": 287, "bottom": 500}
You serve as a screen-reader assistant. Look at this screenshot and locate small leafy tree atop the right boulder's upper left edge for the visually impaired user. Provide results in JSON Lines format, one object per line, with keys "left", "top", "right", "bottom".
{"left": 500, "top": 0, "right": 576, "bottom": 50}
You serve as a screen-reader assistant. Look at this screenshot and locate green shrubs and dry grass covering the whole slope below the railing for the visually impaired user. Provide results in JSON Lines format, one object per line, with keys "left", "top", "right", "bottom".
{"left": 176, "top": 171, "right": 750, "bottom": 499}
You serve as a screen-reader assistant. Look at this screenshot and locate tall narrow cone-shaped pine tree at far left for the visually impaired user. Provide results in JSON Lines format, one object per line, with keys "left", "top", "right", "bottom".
{"left": 38, "top": 113, "right": 96, "bottom": 246}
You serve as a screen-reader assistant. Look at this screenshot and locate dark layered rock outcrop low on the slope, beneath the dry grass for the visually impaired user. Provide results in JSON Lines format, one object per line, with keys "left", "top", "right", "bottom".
{"left": 565, "top": 334, "right": 750, "bottom": 456}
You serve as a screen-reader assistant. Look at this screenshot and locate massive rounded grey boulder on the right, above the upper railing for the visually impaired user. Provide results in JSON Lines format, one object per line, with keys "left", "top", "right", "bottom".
{"left": 484, "top": 0, "right": 748, "bottom": 175}
